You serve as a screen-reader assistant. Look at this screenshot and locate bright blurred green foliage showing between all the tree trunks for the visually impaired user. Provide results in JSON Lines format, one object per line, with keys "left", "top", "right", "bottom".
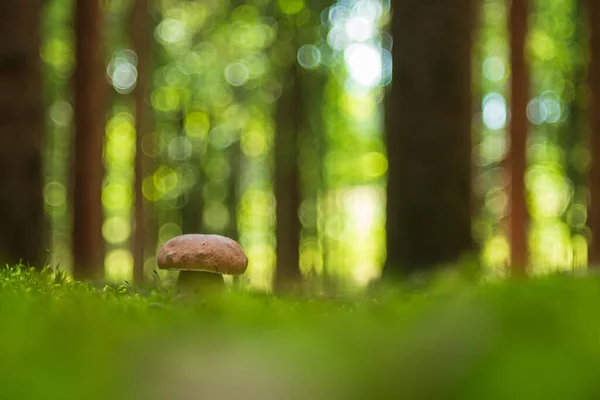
{"left": 41, "top": 0, "right": 589, "bottom": 290}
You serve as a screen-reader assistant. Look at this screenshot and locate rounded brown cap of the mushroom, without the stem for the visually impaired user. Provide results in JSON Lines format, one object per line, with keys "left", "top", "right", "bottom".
{"left": 157, "top": 234, "right": 248, "bottom": 275}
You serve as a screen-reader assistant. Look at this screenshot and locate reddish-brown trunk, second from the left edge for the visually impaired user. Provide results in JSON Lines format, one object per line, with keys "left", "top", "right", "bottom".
{"left": 73, "top": 0, "right": 106, "bottom": 279}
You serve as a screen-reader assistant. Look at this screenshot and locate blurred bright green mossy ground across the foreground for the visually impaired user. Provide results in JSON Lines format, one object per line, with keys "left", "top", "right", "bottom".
{"left": 0, "top": 268, "right": 600, "bottom": 400}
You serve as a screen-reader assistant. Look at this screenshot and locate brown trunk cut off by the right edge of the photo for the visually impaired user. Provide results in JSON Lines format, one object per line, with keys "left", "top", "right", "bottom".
{"left": 587, "top": 0, "right": 600, "bottom": 267}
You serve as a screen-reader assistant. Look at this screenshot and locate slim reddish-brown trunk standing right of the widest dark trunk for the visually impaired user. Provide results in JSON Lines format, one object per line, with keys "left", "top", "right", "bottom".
{"left": 507, "top": 1, "right": 529, "bottom": 276}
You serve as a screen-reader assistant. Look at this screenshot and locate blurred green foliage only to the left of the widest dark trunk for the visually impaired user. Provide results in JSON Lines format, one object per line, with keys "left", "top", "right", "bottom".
{"left": 42, "top": 0, "right": 391, "bottom": 289}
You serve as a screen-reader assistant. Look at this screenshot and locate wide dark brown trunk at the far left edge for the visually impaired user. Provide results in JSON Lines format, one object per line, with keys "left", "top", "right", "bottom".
{"left": 0, "top": 0, "right": 45, "bottom": 266}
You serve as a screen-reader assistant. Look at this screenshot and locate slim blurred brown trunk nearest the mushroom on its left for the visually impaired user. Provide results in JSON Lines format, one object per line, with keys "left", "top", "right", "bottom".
{"left": 131, "top": 0, "right": 152, "bottom": 283}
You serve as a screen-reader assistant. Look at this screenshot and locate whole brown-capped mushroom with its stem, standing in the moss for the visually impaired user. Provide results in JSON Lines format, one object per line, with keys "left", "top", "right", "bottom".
{"left": 157, "top": 234, "right": 248, "bottom": 293}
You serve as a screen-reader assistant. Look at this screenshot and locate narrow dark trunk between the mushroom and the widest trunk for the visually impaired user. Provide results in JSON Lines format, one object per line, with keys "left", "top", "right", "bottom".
{"left": 275, "top": 63, "right": 302, "bottom": 291}
